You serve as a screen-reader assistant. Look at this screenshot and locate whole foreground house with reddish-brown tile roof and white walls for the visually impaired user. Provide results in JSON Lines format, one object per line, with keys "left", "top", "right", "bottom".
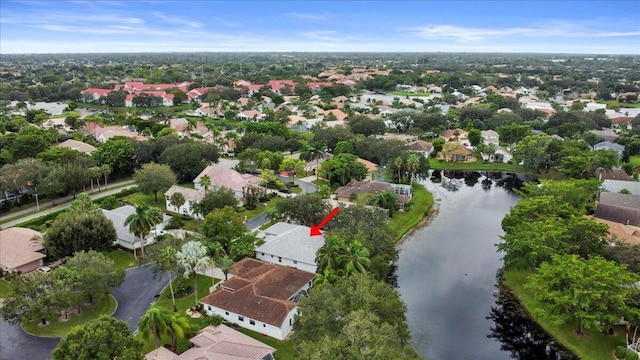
{"left": 200, "top": 258, "right": 315, "bottom": 340}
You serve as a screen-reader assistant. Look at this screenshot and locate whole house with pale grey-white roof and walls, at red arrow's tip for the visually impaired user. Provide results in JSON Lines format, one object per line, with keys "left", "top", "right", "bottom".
{"left": 256, "top": 222, "right": 325, "bottom": 273}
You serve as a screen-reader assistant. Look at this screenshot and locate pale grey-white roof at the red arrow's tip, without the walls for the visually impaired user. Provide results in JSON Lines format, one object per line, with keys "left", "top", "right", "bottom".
{"left": 256, "top": 222, "right": 325, "bottom": 264}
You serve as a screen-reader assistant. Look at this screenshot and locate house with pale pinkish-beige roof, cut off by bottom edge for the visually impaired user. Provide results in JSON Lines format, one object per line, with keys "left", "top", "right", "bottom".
{"left": 145, "top": 324, "right": 276, "bottom": 360}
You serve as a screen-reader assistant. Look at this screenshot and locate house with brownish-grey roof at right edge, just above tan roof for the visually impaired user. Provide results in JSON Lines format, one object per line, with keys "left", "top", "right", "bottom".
{"left": 594, "top": 192, "right": 640, "bottom": 226}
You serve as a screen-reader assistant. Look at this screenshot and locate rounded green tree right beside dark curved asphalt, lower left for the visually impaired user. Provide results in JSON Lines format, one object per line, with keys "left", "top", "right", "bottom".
{"left": 66, "top": 250, "right": 125, "bottom": 304}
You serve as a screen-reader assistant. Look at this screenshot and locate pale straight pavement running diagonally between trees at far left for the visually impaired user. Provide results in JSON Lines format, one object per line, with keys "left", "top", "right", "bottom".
{"left": 0, "top": 180, "right": 135, "bottom": 229}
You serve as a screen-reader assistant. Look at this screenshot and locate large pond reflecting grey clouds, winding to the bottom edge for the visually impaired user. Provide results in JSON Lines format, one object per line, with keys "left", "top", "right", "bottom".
{"left": 397, "top": 171, "right": 575, "bottom": 360}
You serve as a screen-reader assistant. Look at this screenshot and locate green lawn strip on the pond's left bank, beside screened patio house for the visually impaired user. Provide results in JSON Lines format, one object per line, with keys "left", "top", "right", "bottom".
{"left": 388, "top": 183, "right": 433, "bottom": 241}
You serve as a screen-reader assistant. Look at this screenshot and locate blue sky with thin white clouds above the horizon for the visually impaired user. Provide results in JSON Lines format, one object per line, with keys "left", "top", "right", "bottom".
{"left": 0, "top": 0, "right": 640, "bottom": 54}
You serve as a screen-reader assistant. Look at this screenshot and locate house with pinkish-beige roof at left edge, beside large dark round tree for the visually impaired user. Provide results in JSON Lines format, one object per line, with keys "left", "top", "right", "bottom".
{"left": 0, "top": 227, "right": 47, "bottom": 274}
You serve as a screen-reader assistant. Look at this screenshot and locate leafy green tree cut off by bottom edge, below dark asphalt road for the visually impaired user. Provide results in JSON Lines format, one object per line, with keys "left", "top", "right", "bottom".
{"left": 52, "top": 315, "right": 144, "bottom": 360}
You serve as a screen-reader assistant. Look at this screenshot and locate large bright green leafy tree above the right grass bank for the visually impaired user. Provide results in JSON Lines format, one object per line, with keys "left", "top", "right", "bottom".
{"left": 525, "top": 255, "right": 640, "bottom": 334}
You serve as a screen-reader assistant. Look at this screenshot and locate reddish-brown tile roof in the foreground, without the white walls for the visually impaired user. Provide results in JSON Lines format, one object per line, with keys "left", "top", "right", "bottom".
{"left": 200, "top": 258, "right": 315, "bottom": 327}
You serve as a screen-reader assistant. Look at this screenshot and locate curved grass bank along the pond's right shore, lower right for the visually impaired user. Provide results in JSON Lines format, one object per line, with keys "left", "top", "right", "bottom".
{"left": 504, "top": 271, "right": 625, "bottom": 360}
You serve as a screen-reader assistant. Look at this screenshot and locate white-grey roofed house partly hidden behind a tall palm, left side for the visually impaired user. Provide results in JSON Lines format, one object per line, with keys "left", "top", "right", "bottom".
{"left": 100, "top": 205, "right": 171, "bottom": 250}
